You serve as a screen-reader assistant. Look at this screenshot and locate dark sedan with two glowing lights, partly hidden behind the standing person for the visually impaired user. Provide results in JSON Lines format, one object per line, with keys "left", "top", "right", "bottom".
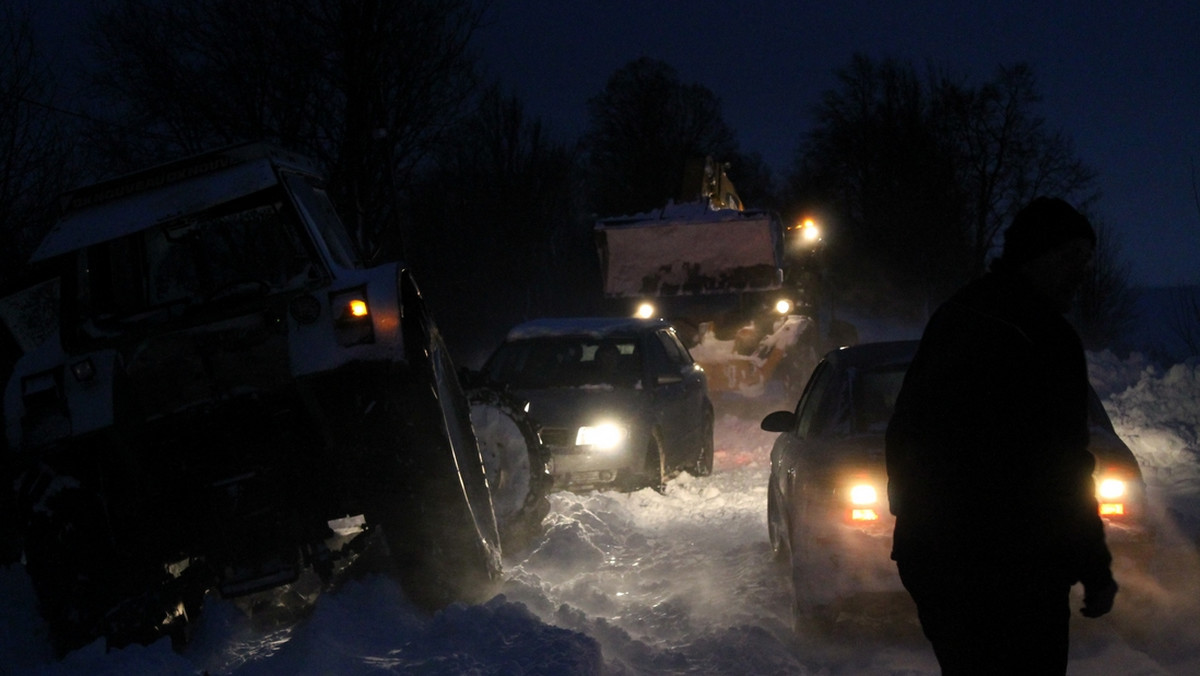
{"left": 762, "top": 341, "right": 1147, "bottom": 603}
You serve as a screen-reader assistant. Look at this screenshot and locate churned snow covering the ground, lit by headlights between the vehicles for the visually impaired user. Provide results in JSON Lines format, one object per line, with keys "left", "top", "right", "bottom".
{"left": 7, "top": 353, "right": 1200, "bottom": 676}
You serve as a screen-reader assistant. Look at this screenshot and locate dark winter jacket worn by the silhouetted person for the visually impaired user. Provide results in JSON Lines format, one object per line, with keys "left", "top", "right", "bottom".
{"left": 887, "top": 271, "right": 1111, "bottom": 585}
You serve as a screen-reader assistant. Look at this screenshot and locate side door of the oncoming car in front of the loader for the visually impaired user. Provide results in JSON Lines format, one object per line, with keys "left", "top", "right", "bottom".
{"left": 647, "top": 329, "right": 704, "bottom": 467}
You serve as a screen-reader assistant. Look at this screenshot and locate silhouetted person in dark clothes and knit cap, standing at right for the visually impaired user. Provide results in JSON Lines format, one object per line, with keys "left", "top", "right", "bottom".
{"left": 886, "top": 197, "right": 1117, "bottom": 675}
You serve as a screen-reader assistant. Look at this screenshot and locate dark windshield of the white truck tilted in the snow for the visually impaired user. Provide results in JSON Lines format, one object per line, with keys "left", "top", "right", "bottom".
{"left": 80, "top": 191, "right": 317, "bottom": 328}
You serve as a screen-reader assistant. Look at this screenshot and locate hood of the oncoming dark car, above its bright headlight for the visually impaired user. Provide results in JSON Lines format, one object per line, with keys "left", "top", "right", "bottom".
{"left": 514, "top": 385, "right": 646, "bottom": 427}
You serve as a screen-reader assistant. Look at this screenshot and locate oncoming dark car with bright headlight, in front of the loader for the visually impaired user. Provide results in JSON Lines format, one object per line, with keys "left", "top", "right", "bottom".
{"left": 481, "top": 317, "right": 713, "bottom": 490}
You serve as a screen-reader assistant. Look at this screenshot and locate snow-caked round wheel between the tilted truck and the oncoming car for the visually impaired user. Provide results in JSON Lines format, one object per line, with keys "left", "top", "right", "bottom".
{"left": 467, "top": 388, "right": 552, "bottom": 550}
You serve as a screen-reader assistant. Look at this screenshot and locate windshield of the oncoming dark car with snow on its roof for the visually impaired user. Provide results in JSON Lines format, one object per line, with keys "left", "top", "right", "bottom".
{"left": 486, "top": 336, "right": 641, "bottom": 389}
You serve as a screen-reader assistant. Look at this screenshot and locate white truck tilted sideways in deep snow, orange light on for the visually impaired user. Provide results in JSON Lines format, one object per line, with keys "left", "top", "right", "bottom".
{"left": 5, "top": 144, "right": 500, "bottom": 652}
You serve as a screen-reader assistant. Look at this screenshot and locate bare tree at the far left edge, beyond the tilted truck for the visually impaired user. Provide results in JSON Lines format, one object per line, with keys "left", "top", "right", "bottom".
{"left": 0, "top": 2, "right": 76, "bottom": 283}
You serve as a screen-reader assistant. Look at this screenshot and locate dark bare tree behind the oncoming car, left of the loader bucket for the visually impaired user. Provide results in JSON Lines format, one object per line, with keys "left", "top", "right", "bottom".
{"left": 408, "top": 86, "right": 588, "bottom": 357}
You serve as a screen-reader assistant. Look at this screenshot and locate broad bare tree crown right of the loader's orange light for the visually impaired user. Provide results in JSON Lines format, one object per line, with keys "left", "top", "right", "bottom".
{"left": 790, "top": 55, "right": 1127, "bottom": 324}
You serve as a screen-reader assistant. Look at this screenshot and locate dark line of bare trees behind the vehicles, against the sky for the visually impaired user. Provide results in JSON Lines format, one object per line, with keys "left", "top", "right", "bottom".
{"left": 0, "top": 0, "right": 1132, "bottom": 363}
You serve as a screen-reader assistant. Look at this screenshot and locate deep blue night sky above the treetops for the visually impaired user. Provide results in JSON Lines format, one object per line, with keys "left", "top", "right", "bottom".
{"left": 476, "top": 0, "right": 1200, "bottom": 286}
